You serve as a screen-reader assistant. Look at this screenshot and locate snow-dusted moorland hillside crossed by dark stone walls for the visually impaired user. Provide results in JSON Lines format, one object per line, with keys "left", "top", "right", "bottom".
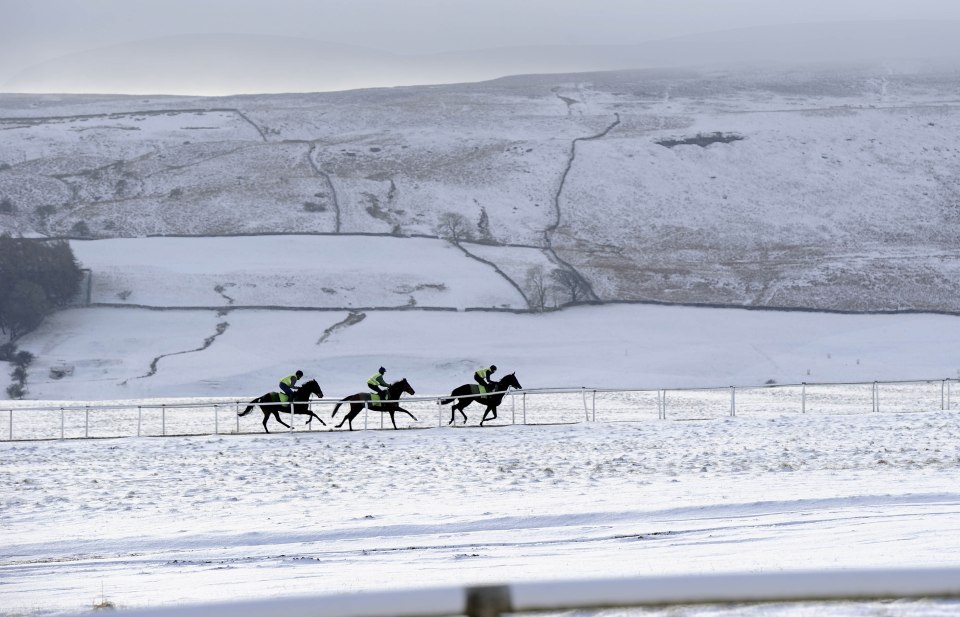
{"left": 0, "top": 61, "right": 960, "bottom": 312}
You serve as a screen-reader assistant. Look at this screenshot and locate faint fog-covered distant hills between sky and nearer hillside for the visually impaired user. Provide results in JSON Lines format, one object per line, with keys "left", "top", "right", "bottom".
{"left": 0, "top": 20, "right": 960, "bottom": 95}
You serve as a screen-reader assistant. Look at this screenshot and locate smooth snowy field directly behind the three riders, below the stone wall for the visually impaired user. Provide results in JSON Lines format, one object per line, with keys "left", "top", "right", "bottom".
{"left": 7, "top": 305, "right": 960, "bottom": 408}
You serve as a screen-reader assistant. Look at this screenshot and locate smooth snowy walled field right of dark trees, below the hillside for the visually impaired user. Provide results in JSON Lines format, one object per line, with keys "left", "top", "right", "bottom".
{"left": 72, "top": 236, "right": 526, "bottom": 309}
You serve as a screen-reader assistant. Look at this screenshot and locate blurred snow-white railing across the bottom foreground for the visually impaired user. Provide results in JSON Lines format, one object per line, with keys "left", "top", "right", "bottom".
{"left": 56, "top": 568, "right": 960, "bottom": 617}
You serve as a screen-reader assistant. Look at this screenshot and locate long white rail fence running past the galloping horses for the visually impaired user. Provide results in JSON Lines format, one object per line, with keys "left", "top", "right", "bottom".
{"left": 0, "top": 379, "right": 960, "bottom": 441}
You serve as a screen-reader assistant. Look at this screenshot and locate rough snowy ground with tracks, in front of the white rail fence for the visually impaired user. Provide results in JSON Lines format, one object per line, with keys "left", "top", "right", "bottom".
{"left": 0, "top": 410, "right": 960, "bottom": 616}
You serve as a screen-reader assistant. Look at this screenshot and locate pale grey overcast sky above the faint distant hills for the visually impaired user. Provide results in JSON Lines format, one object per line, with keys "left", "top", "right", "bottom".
{"left": 0, "top": 0, "right": 960, "bottom": 92}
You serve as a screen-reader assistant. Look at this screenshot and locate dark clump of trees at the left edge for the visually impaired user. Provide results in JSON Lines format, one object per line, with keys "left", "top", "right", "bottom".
{"left": 0, "top": 235, "right": 83, "bottom": 340}
